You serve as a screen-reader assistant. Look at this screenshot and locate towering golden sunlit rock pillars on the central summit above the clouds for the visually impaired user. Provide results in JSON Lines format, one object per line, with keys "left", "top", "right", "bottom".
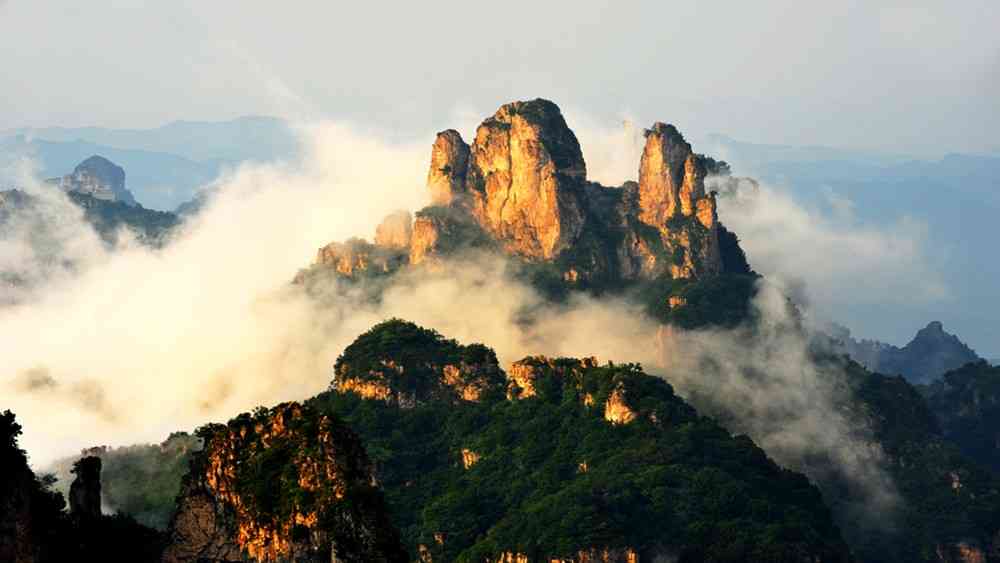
{"left": 300, "top": 99, "right": 748, "bottom": 286}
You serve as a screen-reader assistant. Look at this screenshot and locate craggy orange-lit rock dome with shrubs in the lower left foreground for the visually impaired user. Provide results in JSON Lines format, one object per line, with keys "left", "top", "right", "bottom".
{"left": 163, "top": 403, "right": 407, "bottom": 563}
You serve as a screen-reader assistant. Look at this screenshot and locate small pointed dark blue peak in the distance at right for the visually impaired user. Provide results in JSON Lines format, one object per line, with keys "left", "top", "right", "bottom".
{"left": 835, "top": 321, "right": 980, "bottom": 383}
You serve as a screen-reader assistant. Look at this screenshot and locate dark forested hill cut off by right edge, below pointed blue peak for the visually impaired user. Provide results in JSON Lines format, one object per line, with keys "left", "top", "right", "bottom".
{"left": 920, "top": 360, "right": 1000, "bottom": 474}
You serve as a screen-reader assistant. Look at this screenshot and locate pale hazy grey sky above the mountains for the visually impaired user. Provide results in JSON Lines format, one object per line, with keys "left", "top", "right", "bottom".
{"left": 0, "top": 0, "right": 1000, "bottom": 155}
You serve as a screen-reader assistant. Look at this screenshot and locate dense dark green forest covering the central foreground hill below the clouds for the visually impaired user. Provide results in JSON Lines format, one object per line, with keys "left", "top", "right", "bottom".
{"left": 312, "top": 323, "right": 847, "bottom": 561}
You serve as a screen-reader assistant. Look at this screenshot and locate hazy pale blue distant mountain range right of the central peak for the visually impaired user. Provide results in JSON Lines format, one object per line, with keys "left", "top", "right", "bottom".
{"left": 699, "top": 135, "right": 1000, "bottom": 357}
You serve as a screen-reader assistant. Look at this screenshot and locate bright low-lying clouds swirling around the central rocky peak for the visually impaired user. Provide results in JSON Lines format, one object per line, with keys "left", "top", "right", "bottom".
{"left": 0, "top": 113, "right": 943, "bottom": 532}
